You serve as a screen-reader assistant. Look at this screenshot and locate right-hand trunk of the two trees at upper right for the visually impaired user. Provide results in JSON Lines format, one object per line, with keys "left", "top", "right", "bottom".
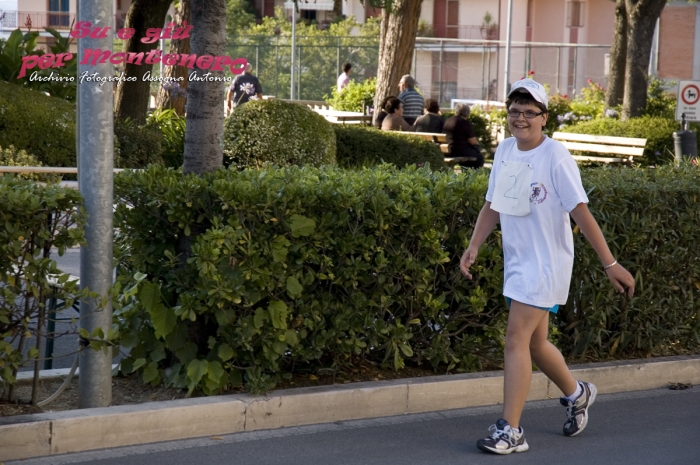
{"left": 622, "top": 0, "right": 666, "bottom": 120}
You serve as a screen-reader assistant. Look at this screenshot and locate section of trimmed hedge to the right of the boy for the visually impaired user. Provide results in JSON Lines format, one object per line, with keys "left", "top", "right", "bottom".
{"left": 559, "top": 165, "right": 700, "bottom": 357}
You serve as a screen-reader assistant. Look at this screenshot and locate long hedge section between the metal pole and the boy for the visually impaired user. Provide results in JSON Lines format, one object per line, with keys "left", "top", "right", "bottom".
{"left": 115, "top": 165, "right": 498, "bottom": 393}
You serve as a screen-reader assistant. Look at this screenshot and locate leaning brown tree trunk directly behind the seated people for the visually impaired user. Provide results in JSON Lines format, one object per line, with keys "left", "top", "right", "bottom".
{"left": 374, "top": 0, "right": 423, "bottom": 125}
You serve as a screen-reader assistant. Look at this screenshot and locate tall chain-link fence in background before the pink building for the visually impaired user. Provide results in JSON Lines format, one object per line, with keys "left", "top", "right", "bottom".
{"left": 228, "top": 35, "right": 609, "bottom": 106}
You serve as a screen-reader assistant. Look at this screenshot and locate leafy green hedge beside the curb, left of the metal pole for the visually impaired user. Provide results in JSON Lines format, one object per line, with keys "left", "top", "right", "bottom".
{"left": 0, "top": 175, "right": 85, "bottom": 397}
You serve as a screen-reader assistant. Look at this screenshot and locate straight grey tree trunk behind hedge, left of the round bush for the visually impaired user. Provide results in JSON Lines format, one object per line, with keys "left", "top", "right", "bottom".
{"left": 183, "top": 0, "right": 226, "bottom": 174}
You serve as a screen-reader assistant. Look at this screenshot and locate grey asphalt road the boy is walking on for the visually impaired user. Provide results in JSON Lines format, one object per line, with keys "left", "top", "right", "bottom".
{"left": 6, "top": 387, "right": 700, "bottom": 465}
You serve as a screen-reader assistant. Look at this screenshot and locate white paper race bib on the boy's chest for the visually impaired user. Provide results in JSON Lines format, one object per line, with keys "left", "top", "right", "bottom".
{"left": 491, "top": 161, "right": 534, "bottom": 216}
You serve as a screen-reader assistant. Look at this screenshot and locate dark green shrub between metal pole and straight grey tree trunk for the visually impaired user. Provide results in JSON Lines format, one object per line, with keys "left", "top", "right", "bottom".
{"left": 114, "top": 118, "right": 164, "bottom": 168}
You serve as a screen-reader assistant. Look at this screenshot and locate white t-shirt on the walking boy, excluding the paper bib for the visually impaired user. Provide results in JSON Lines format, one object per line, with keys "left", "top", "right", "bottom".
{"left": 486, "top": 137, "right": 588, "bottom": 308}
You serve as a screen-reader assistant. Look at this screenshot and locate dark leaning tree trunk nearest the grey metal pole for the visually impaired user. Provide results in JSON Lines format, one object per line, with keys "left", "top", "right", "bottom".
{"left": 115, "top": 0, "right": 172, "bottom": 124}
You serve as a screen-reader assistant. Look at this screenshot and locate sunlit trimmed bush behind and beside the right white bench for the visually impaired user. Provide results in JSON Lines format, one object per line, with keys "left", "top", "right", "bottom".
{"left": 561, "top": 116, "right": 679, "bottom": 166}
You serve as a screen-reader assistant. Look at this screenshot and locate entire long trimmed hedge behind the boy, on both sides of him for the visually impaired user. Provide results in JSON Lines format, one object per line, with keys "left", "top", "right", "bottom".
{"left": 115, "top": 165, "right": 700, "bottom": 394}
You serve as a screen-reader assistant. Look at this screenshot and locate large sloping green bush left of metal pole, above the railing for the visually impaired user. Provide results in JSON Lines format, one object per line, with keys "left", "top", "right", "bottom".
{"left": 0, "top": 82, "right": 75, "bottom": 166}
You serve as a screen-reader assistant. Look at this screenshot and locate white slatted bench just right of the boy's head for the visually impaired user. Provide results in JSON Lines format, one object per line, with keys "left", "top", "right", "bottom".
{"left": 552, "top": 132, "right": 647, "bottom": 165}
